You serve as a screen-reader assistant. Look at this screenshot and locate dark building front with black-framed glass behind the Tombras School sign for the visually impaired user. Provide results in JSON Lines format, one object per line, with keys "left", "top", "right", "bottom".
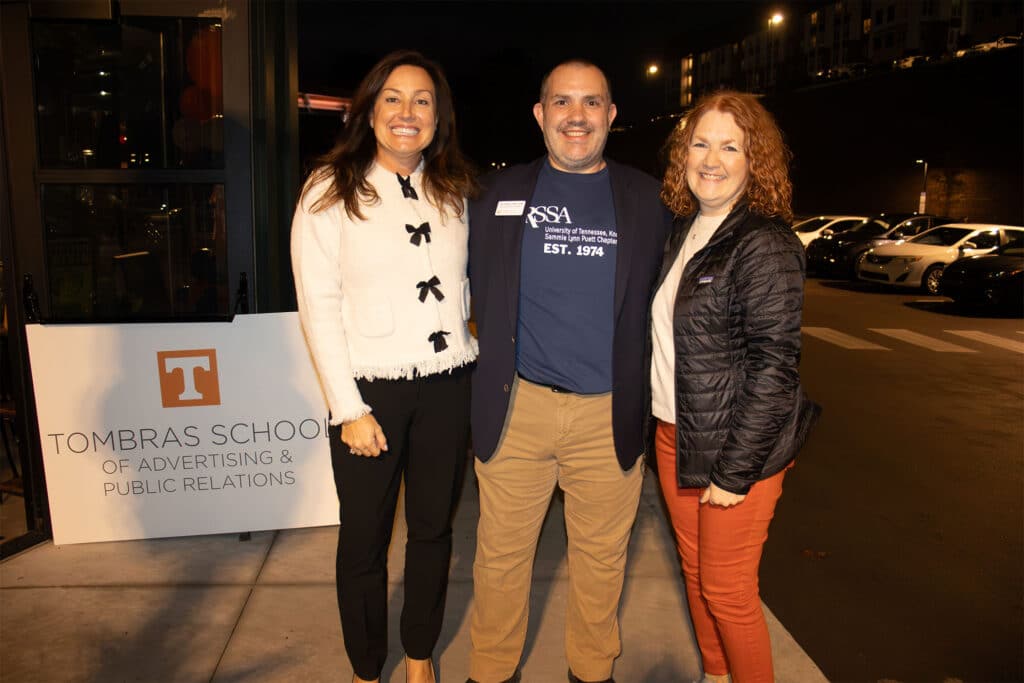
{"left": 0, "top": 0, "right": 301, "bottom": 556}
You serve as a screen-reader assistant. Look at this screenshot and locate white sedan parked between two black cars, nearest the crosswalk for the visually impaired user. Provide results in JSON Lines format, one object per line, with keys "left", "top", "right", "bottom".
{"left": 857, "top": 223, "right": 1024, "bottom": 294}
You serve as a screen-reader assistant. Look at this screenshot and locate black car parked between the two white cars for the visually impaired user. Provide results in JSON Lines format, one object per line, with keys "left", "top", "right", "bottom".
{"left": 807, "top": 213, "right": 956, "bottom": 280}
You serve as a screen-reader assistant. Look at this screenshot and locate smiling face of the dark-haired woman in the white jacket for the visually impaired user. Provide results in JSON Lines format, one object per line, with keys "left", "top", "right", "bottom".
{"left": 370, "top": 65, "right": 437, "bottom": 175}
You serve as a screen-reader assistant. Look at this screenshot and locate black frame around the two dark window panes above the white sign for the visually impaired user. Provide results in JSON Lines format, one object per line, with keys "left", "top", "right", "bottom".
{"left": 0, "top": 0, "right": 255, "bottom": 323}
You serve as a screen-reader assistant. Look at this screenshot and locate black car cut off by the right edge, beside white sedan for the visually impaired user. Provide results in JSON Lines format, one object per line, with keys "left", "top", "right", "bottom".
{"left": 939, "top": 232, "right": 1024, "bottom": 311}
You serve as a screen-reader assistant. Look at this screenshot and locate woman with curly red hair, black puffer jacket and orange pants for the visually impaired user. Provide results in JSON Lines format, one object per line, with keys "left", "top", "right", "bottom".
{"left": 651, "top": 91, "right": 820, "bottom": 683}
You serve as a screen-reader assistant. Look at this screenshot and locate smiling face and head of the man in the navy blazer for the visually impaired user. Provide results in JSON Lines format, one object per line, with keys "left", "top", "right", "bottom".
{"left": 534, "top": 63, "right": 615, "bottom": 173}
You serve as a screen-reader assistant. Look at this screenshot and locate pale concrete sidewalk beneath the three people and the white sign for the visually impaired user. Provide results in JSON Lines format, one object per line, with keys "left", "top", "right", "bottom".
{"left": 0, "top": 472, "right": 825, "bottom": 683}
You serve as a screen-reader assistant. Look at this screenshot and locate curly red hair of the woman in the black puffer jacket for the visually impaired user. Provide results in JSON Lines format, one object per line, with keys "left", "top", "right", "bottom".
{"left": 662, "top": 90, "right": 793, "bottom": 222}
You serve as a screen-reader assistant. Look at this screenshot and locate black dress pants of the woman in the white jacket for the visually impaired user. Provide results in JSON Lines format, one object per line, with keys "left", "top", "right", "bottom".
{"left": 331, "top": 366, "right": 470, "bottom": 680}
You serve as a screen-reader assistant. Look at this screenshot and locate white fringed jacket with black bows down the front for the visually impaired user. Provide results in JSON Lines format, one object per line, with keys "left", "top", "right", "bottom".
{"left": 292, "top": 164, "right": 477, "bottom": 425}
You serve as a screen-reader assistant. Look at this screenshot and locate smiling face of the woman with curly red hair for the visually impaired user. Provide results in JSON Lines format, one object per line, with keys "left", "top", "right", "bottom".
{"left": 686, "top": 110, "right": 750, "bottom": 216}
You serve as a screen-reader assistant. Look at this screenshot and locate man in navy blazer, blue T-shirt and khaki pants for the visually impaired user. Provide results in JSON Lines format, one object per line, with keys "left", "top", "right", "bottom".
{"left": 469, "top": 60, "right": 671, "bottom": 683}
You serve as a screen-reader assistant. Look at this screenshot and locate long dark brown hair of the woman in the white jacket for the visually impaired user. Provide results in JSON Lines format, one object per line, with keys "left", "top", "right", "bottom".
{"left": 303, "top": 50, "right": 477, "bottom": 220}
